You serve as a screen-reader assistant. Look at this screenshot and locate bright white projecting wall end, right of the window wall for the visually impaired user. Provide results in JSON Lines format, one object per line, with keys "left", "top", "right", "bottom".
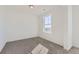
{"left": 64, "top": 6, "right": 72, "bottom": 50}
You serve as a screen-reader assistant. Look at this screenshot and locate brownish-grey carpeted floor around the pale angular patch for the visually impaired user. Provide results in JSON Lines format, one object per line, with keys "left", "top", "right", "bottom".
{"left": 1, "top": 37, "right": 79, "bottom": 54}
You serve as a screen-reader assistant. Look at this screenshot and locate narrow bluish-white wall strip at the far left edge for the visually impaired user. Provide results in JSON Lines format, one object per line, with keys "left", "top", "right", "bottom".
{"left": 0, "top": 6, "right": 6, "bottom": 52}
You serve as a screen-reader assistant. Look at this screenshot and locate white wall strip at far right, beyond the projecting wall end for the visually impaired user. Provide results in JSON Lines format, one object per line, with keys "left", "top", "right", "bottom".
{"left": 72, "top": 6, "right": 79, "bottom": 48}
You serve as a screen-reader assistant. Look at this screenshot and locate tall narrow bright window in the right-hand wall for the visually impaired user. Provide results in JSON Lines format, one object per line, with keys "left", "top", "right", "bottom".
{"left": 43, "top": 16, "right": 52, "bottom": 33}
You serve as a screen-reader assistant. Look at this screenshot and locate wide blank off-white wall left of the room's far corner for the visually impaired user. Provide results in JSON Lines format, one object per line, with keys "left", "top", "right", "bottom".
{"left": 6, "top": 6, "right": 37, "bottom": 41}
